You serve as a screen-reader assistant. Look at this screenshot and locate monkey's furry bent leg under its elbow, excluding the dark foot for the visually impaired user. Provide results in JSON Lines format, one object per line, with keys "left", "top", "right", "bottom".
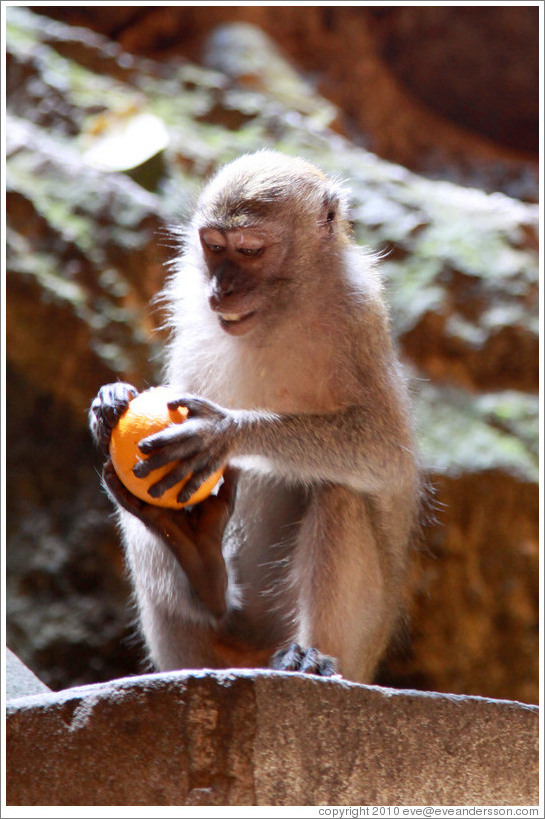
{"left": 282, "top": 486, "right": 397, "bottom": 682}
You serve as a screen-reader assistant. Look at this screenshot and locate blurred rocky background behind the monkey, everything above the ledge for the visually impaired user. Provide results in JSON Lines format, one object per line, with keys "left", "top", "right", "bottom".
{"left": 6, "top": 4, "right": 539, "bottom": 703}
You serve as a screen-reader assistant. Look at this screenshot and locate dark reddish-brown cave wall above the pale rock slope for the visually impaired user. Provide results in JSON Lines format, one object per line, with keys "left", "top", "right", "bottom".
{"left": 31, "top": 4, "right": 539, "bottom": 201}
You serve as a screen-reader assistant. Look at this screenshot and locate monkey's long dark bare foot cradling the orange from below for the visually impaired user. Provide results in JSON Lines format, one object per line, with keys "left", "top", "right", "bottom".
{"left": 103, "top": 460, "right": 238, "bottom": 618}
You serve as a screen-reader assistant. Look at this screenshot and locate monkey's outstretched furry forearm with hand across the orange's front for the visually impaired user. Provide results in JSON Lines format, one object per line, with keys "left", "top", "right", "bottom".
{"left": 131, "top": 396, "right": 414, "bottom": 502}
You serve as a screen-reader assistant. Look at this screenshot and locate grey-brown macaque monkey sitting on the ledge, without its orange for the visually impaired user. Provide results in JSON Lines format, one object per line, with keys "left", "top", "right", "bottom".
{"left": 90, "top": 151, "right": 419, "bottom": 682}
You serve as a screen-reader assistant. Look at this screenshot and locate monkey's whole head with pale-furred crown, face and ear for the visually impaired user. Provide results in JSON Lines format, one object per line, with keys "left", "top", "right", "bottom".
{"left": 189, "top": 151, "right": 348, "bottom": 336}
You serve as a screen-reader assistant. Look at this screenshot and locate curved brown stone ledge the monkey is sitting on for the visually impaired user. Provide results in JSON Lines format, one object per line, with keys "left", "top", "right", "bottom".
{"left": 7, "top": 671, "right": 539, "bottom": 806}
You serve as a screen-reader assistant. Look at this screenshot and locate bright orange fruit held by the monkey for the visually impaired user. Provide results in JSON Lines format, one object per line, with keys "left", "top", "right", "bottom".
{"left": 110, "top": 387, "right": 223, "bottom": 509}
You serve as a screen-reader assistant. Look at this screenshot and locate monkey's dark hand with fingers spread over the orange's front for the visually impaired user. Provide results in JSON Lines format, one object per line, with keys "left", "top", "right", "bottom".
{"left": 133, "top": 396, "right": 237, "bottom": 503}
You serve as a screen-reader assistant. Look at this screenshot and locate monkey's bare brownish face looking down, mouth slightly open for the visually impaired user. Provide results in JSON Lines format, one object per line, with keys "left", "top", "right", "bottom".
{"left": 199, "top": 227, "right": 286, "bottom": 336}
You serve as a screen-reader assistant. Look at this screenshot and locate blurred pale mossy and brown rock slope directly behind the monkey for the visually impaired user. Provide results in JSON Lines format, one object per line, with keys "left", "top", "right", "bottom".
{"left": 6, "top": 6, "right": 539, "bottom": 702}
